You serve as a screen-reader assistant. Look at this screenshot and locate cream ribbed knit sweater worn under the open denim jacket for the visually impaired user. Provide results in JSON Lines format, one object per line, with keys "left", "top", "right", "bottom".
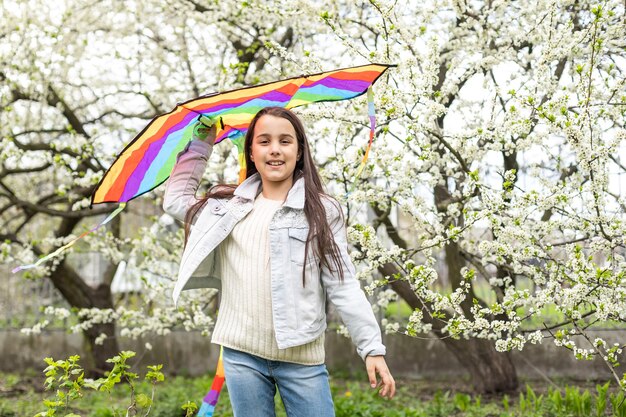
{"left": 211, "top": 194, "right": 324, "bottom": 365}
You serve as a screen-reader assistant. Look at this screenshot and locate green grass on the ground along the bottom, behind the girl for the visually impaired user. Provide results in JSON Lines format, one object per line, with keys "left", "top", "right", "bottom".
{"left": 0, "top": 372, "right": 626, "bottom": 417}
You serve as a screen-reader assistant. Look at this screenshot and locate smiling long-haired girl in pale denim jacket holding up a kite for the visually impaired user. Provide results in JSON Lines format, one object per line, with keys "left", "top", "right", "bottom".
{"left": 163, "top": 107, "right": 395, "bottom": 417}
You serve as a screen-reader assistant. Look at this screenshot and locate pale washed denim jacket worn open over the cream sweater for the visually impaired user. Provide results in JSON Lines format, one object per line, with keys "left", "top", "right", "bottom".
{"left": 163, "top": 140, "right": 385, "bottom": 360}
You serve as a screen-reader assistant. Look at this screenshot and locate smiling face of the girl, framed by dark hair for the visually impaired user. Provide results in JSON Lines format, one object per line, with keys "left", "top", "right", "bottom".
{"left": 250, "top": 114, "right": 299, "bottom": 183}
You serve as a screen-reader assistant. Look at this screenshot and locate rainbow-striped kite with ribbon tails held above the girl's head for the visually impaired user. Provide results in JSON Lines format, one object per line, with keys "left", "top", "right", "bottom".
{"left": 13, "top": 64, "right": 394, "bottom": 272}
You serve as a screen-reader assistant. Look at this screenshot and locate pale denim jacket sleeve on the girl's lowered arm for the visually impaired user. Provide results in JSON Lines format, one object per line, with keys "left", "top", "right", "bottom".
{"left": 321, "top": 200, "right": 386, "bottom": 360}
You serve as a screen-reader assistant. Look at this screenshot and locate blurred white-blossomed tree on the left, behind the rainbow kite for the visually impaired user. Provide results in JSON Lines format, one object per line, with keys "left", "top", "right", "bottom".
{"left": 0, "top": 0, "right": 300, "bottom": 370}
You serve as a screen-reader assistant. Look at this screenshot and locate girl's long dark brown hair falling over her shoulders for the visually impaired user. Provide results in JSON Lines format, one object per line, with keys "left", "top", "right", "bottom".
{"left": 185, "top": 107, "right": 344, "bottom": 285}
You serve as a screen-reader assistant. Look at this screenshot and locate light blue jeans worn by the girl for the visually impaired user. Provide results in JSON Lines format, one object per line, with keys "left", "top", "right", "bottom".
{"left": 223, "top": 347, "right": 335, "bottom": 417}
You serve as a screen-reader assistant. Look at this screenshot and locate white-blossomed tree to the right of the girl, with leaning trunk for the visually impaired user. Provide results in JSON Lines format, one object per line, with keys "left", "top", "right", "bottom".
{"left": 304, "top": 0, "right": 626, "bottom": 391}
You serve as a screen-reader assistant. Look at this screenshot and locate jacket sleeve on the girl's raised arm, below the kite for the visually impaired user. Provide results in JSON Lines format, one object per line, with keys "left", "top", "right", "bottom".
{"left": 163, "top": 140, "right": 213, "bottom": 222}
